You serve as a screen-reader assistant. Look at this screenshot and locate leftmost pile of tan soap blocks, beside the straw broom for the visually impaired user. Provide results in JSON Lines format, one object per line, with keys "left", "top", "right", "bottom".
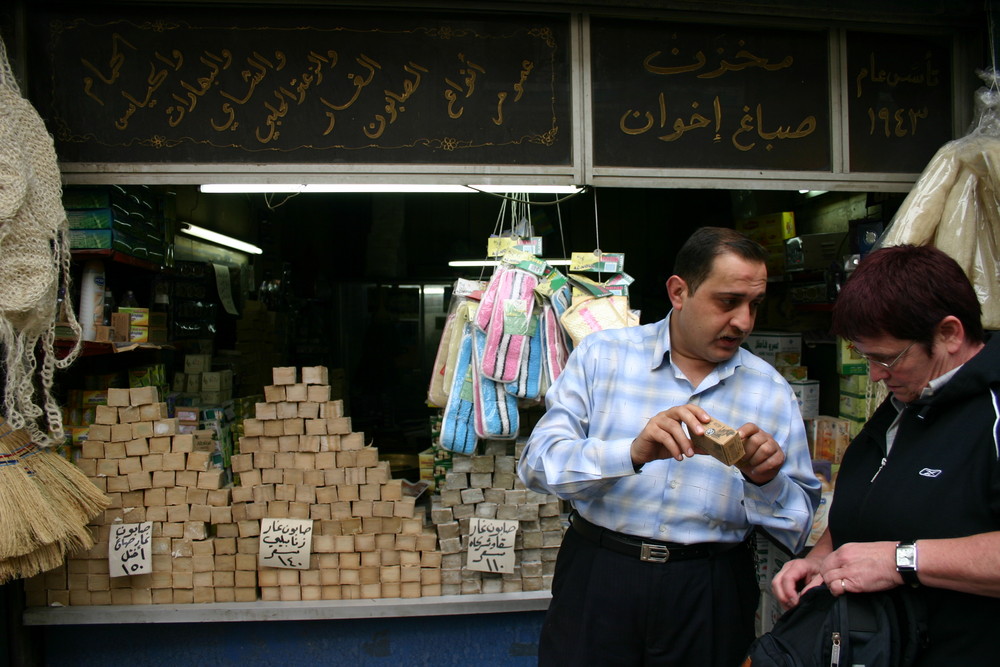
{"left": 25, "top": 387, "right": 257, "bottom": 606}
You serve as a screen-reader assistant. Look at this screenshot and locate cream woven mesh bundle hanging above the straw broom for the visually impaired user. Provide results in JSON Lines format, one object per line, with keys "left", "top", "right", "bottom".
{"left": 0, "top": 39, "right": 81, "bottom": 445}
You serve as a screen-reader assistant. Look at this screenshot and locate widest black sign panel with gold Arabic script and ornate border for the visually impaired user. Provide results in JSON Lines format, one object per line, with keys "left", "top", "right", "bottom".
{"left": 35, "top": 9, "right": 572, "bottom": 164}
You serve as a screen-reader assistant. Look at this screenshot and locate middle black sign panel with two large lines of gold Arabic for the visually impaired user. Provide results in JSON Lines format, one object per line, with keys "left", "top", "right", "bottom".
{"left": 590, "top": 19, "right": 831, "bottom": 170}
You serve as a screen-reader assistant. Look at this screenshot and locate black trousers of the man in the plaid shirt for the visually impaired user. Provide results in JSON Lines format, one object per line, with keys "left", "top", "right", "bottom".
{"left": 538, "top": 528, "right": 760, "bottom": 667}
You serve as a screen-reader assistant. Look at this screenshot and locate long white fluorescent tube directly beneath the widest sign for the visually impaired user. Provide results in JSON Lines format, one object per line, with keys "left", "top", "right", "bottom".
{"left": 199, "top": 183, "right": 583, "bottom": 194}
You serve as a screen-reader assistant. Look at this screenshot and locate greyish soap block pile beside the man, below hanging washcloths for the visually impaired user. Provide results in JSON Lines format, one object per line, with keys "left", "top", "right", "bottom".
{"left": 431, "top": 440, "right": 566, "bottom": 595}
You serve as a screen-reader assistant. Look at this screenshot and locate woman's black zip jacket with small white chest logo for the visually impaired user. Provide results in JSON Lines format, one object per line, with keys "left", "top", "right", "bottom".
{"left": 829, "top": 335, "right": 1000, "bottom": 667}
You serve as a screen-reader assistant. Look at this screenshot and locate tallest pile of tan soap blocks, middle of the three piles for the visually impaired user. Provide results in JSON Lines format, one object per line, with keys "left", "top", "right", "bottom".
{"left": 232, "top": 367, "right": 442, "bottom": 601}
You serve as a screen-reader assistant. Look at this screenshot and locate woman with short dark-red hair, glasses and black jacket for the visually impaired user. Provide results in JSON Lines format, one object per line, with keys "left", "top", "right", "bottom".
{"left": 773, "top": 245, "right": 1000, "bottom": 667}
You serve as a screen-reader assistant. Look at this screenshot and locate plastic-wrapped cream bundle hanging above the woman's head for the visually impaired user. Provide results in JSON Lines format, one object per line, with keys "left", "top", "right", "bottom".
{"left": 879, "top": 70, "right": 1000, "bottom": 329}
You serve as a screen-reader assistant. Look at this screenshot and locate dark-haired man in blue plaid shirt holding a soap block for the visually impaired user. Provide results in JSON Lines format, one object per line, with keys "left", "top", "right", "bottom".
{"left": 518, "top": 227, "right": 819, "bottom": 666}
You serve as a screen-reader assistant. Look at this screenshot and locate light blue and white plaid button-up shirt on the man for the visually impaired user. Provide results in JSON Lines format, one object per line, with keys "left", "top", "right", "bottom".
{"left": 518, "top": 315, "right": 820, "bottom": 553}
